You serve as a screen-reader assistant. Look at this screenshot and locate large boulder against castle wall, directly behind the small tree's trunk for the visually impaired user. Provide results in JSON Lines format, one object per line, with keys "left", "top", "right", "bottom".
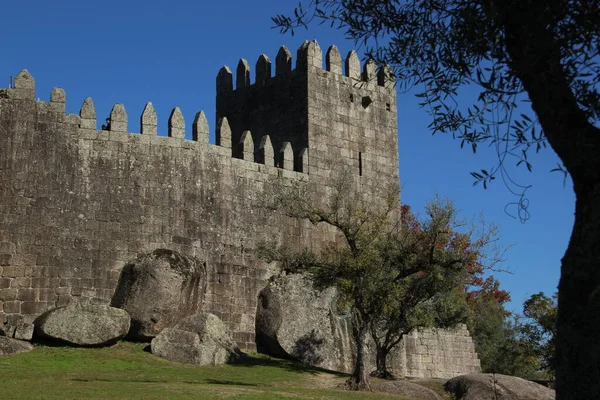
{"left": 256, "top": 274, "right": 354, "bottom": 372}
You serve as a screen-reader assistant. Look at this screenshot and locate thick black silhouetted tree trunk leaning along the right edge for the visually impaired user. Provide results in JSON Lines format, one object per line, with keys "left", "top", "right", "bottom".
{"left": 496, "top": 0, "right": 600, "bottom": 400}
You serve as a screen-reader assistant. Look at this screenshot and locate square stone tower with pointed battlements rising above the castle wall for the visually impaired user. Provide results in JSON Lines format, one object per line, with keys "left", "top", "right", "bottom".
{"left": 217, "top": 41, "right": 399, "bottom": 185}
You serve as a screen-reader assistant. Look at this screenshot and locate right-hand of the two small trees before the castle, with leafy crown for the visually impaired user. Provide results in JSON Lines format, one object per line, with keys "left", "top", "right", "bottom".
{"left": 370, "top": 202, "right": 480, "bottom": 379}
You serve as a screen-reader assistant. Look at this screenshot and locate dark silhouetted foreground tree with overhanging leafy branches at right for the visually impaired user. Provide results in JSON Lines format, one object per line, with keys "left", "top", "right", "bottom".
{"left": 274, "top": 0, "right": 600, "bottom": 399}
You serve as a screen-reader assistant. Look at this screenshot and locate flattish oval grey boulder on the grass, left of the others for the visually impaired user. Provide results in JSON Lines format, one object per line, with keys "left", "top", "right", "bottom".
{"left": 35, "top": 304, "right": 130, "bottom": 346}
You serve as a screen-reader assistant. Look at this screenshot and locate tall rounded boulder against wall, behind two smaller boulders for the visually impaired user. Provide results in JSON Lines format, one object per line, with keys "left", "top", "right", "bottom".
{"left": 111, "top": 249, "right": 206, "bottom": 341}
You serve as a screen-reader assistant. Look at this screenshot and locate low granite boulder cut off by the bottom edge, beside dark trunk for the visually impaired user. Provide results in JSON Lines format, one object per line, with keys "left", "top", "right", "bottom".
{"left": 444, "top": 374, "right": 555, "bottom": 400}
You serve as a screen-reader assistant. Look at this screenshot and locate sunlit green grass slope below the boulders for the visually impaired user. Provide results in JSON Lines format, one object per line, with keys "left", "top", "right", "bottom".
{"left": 0, "top": 342, "right": 412, "bottom": 400}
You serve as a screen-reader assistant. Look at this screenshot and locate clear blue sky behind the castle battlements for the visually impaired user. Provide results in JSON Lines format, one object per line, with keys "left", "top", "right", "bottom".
{"left": 0, "top": 0, "right": 575, "bottom": 312}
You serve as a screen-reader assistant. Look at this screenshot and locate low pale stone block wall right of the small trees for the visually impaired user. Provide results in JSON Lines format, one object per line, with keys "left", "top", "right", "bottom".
{"left": 400, "top": 324, "right": 481, "bottom": 379}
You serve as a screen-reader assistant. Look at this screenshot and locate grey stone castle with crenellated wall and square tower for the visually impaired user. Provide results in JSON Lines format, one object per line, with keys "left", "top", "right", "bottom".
{"left": 0, "top": 41, "right": 478, "bottom": 378}
